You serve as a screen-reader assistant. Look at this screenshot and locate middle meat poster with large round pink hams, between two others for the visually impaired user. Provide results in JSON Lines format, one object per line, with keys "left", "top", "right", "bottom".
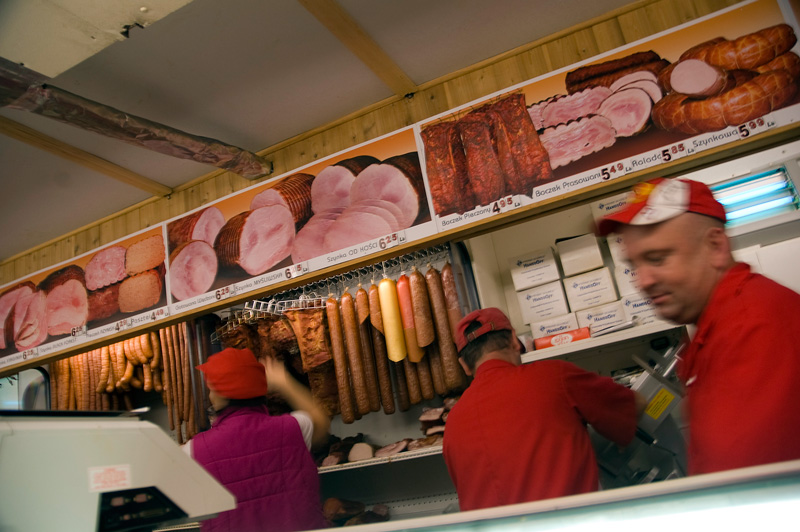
{"left": 167, "top": 128, "right": 436, "bottom": 313}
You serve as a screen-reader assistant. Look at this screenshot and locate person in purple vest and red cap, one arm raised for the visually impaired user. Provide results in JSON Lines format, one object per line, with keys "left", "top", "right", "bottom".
{"left": 185, "top": 348, "right": 330, "bottom": 532}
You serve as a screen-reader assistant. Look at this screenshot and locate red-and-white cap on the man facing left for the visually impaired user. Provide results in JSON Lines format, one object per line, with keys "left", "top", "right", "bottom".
{"left": 597, "top": 177, "right": 727, "bottom": 236}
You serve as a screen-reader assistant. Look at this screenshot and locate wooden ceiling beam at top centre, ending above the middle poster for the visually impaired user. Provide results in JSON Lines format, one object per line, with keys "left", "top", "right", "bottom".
{"left": 297, "top": 0, "right": 418, "bottom": 97}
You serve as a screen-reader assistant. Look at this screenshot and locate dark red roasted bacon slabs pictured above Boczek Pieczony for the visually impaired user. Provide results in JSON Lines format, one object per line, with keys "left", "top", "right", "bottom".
{"left": 421, "top": 93, "right": 552, "bottom": 216}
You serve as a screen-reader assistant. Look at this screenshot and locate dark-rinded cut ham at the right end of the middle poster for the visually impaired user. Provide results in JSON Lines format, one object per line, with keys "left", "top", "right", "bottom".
{"left": 350, "top": 152, "right": 430, "bottom": 232}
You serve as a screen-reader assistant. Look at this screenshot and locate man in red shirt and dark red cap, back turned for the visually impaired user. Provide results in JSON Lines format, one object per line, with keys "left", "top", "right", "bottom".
{"left": 443, "top": 308, "right": 645, "bottom": 510}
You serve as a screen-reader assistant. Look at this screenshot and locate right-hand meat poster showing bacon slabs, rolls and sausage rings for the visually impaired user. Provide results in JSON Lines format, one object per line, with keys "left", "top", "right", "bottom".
{"left": 417, "top": 0, "right": 800, "bottom": 231}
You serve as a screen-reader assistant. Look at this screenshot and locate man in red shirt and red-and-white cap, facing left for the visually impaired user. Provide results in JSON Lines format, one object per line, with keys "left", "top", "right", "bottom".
{"left": 597, "top": 179, "right": 800, "bottom": 474}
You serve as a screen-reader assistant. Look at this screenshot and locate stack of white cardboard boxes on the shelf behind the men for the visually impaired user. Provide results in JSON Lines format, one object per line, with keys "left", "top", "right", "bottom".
{"left": 509, "top": 196, "right": 658, "bottom": 349}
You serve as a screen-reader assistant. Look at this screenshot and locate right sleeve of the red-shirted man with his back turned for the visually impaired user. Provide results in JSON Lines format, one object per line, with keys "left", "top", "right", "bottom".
{"left": 562, "top": 362, "right": 637, "bottom": 445}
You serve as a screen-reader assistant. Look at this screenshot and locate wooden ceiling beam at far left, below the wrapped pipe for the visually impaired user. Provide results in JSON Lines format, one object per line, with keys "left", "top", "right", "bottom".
{"left": 0, "top": 116, "right": 172, "bottom": 196}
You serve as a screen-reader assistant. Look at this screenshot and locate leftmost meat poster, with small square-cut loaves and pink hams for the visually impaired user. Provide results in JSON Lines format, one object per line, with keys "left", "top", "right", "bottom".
{"left": 0, "top": 224, "right": 169, "bottom": 368}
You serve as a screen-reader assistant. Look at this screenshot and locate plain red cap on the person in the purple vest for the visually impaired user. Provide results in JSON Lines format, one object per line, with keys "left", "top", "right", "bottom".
{"left": 197, "top": 347, "right": 267, "bottom": 399}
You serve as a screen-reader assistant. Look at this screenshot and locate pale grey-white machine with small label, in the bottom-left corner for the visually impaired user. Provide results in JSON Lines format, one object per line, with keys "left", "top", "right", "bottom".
{"left": 0, "top": 411, "right": 236, "bottom": 532}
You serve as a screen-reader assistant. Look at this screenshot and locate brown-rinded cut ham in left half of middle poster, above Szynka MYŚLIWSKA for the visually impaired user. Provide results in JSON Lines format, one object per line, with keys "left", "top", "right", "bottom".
{"left": 214, "top": 205, "right": 296, "bottom": 275}
